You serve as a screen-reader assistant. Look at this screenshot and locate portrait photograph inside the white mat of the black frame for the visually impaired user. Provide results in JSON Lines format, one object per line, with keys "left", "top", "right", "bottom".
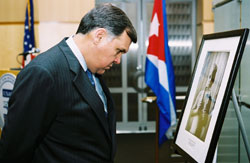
{"left": 186, "top": 51, "right": 229, "bottom": 141}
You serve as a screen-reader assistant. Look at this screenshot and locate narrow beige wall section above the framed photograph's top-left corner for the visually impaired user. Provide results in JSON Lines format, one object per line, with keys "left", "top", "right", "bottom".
{"left": 196, "top": 0, "right": 214, "bottom": 51}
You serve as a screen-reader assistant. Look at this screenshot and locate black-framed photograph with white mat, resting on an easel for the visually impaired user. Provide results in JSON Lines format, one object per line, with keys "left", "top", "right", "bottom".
{"left": 174, "top": 29, "right": 249, "bottom": 163}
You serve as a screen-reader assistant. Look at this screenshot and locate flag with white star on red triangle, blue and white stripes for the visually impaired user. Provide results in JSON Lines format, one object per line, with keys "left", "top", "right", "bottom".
{"left": 145, "top": 0, "right": 176, "bottom": 145}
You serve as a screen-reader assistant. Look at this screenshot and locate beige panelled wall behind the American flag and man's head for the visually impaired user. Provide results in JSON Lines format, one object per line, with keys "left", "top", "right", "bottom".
{"left": 0, "top": 0, "right": 95, "bottom": 69}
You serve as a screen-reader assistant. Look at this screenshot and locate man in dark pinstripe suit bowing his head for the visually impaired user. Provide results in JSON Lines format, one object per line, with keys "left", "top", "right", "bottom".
{"left": 0, "top": 4, "right": 137, "bottom": 163}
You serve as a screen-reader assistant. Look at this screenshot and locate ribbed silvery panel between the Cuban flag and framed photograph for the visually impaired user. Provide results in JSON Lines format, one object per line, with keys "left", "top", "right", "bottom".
{"left": 167, "top": 2, "right": 192, "bottom": 86}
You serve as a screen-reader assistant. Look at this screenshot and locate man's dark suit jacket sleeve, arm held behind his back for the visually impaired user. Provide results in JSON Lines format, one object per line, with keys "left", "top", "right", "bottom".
{"left": 0, "top": 66, "right": 54, "bottom": 162}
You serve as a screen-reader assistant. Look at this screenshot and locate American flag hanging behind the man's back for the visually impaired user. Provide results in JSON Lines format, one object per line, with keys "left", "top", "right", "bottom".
{"left": 22, "top": 0, "right": 35, "bottom": 67}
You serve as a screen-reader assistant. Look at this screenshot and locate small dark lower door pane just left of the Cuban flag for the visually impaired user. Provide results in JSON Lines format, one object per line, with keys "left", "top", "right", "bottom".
{"left": 128, "top": 93, "right": 138, "bottom": 121}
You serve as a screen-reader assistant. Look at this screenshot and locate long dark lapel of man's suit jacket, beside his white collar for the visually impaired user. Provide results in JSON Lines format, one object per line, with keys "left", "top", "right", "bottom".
{"left": 59, "top": 38, "right": 111, "bottom": 139}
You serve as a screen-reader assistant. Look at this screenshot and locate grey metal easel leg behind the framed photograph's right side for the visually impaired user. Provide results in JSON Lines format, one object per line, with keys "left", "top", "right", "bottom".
{"left": 232, "top": 89, "right": 250, "bottom": 162}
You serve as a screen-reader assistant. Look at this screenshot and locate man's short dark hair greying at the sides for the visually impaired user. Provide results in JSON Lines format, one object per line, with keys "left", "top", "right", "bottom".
{"left": 76, "top": 4, "right": 137, "bottom": 43}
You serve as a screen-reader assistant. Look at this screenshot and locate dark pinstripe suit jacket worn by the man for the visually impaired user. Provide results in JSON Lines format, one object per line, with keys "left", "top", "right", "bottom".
{"left": 0, "top": 39, "right": 116, "bottom": 163}
